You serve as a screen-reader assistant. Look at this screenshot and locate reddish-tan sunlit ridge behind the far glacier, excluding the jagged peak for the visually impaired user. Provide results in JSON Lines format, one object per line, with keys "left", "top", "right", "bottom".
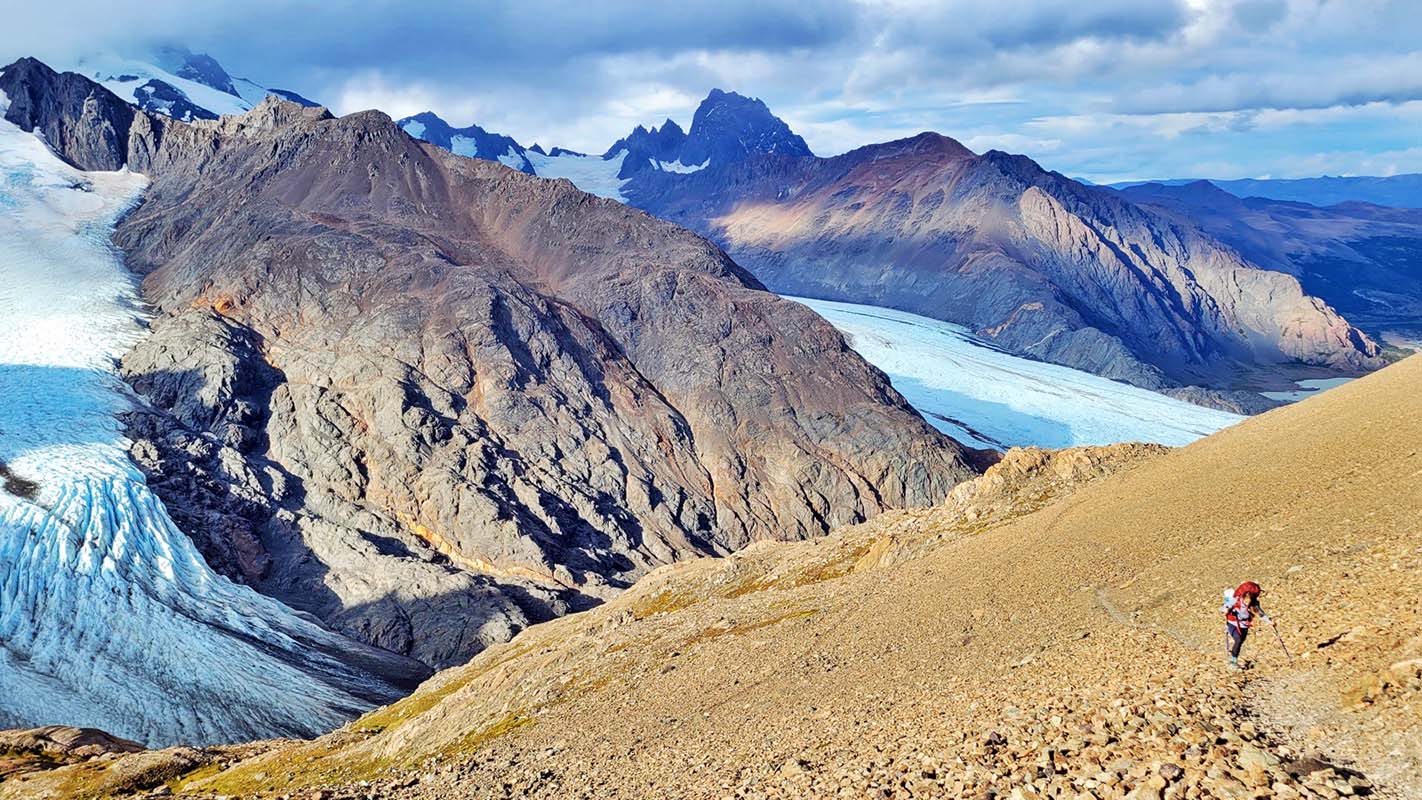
{"left": 624, "top": 134, "right": 1381, "bottom": 388}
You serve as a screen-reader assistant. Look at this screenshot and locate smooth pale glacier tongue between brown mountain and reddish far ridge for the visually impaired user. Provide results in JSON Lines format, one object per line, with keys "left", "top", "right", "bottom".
{"left": 786, "top": 297, "right": 1244, "bottom": 450}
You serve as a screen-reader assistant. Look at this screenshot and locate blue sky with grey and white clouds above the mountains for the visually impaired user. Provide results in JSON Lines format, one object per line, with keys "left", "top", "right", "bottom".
{"left": 0, "top": 0, "right": 1422, "bottom": 182}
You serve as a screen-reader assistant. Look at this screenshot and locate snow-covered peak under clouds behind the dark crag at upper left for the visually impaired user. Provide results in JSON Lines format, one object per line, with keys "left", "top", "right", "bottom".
{"left": 64, "top": 47, "right": 317, "bottom": 122}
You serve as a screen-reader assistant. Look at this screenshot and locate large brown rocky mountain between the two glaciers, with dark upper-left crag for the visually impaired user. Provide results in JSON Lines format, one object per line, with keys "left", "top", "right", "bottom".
{"left": 0, "top": 54, "right": 970, "bottom": 665}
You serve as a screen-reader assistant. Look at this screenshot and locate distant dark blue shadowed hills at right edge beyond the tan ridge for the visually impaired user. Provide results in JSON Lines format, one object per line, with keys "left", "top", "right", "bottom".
{"left": 1122, "top": 179, "right": 1422, "bottom": 343}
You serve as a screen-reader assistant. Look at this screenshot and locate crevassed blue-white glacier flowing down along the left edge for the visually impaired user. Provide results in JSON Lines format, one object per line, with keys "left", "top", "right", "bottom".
{"left": 0, "top": 110, "right": 412, "bottom": 746}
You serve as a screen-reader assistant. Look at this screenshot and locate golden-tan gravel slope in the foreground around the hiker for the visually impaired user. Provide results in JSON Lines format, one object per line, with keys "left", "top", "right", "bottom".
{"left": 177, "top": 358, "right": 1422, "bottom": 796}
